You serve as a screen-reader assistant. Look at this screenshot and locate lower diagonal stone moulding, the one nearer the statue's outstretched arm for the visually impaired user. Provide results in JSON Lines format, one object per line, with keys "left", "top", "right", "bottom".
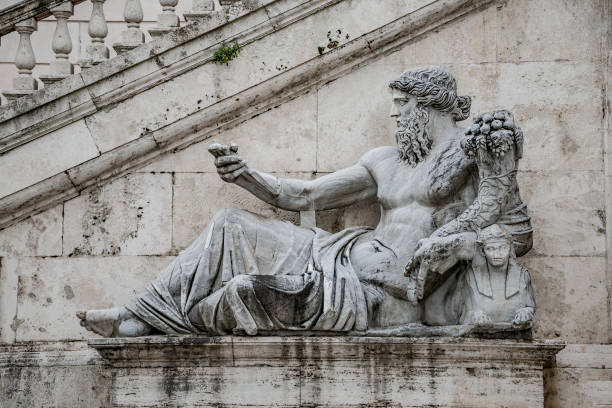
{"left": 0, "top": 0, "right": 496, "bottom": 230}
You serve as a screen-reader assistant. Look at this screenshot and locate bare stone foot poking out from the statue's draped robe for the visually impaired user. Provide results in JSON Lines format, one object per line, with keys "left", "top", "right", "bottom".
{"left": 76, "top": 307, "right": 152, "bottom": 337}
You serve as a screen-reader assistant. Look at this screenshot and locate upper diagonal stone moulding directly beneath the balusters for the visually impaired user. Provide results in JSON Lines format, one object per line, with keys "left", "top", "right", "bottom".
{"left": 0, "top": 0, "right": 342, "bottom": 154}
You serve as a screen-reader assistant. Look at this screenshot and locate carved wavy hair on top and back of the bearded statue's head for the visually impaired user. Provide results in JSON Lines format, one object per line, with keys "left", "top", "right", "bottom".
{"left": 389, "top": 66, "right": 472, "bottom": 121}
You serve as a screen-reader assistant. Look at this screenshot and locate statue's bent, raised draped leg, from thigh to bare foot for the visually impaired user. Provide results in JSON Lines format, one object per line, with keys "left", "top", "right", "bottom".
{"left": 78, "top": 209, "right": 314, "bottom": 337}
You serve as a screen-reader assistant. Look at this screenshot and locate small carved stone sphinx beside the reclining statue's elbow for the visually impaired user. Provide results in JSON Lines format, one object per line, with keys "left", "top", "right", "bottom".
{"left": 459, "top": 224, "right": 535, "bottom": 329}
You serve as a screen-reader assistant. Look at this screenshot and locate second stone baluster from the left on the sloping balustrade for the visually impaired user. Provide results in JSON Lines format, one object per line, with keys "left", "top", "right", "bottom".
{"left": 40, "top": 1, "right": 74, "bottom": 86}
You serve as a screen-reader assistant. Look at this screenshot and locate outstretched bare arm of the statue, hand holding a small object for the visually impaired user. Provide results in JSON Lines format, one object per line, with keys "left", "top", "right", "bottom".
{"left": 209, "top": 143, "right": 377, "bottom": 211}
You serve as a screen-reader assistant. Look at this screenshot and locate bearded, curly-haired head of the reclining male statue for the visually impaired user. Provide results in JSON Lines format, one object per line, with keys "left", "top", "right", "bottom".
{"left": 389, "top": 66, "right": 471, "bottom": 166}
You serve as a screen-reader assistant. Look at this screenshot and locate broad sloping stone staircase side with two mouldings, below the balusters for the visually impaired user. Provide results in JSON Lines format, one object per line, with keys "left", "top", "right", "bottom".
{"left": 0, "top": 0, "right": 492, "bottom": 228}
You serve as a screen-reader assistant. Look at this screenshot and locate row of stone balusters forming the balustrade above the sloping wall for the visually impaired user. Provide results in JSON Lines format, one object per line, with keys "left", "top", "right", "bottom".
{"left": 0, "top": 0, "right": 243, "bottom": 106}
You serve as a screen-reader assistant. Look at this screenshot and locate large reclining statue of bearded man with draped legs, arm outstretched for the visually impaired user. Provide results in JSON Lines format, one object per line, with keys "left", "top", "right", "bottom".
{"left": 77, "top": 67, "right": 528, "bottom": 336}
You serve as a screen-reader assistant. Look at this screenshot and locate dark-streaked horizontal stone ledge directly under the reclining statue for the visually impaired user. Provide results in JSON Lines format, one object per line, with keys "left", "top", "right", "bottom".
{"left": 87, "top": 336, "right": 565, "bottom": 369}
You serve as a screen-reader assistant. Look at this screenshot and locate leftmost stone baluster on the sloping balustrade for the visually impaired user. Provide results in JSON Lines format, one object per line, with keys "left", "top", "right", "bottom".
{"left": 2, "top": 18, "right": 38, "bottom": 101}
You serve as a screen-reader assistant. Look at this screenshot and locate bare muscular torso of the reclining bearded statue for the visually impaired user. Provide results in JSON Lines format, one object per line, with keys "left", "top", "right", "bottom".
{"left": 351, "top": 142, "right": 473, "bottom": 326}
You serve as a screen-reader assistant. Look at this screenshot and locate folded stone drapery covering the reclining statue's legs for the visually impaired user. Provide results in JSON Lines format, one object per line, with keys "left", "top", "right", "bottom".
{"left": 126, "top": 210, "right": 370, "bottom": 334}
